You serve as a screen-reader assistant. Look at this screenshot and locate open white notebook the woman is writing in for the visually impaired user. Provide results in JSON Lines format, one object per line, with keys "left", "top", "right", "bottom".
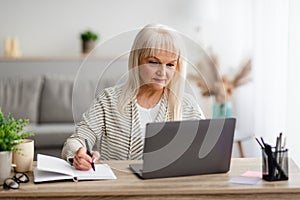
{"left": 33, "top": 154, "right": 117, "bottom": 183}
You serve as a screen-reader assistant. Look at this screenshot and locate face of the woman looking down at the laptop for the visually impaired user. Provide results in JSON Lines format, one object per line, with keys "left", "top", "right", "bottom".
{"left": 139, "top": 51, "right": 178, "bottom": 90}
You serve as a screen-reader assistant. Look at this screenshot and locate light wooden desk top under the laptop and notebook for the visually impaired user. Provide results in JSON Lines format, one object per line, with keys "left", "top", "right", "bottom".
{"left": 0, "top": 158, "right": 300, "bottom": 200}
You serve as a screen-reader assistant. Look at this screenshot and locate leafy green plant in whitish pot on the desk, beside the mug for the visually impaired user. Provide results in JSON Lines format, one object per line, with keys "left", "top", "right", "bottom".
{"left": 0, "top": 108, "right": 33, "bottom": 185}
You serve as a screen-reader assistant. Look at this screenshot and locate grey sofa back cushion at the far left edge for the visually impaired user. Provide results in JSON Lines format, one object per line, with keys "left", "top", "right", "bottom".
{"left": 0, "top": 76, "right": 43, "bottom": 122}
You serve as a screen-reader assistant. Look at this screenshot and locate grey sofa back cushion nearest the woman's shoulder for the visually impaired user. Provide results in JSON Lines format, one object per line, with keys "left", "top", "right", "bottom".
{"left": 39, "top": 74, "right": 95, "bottom": 123}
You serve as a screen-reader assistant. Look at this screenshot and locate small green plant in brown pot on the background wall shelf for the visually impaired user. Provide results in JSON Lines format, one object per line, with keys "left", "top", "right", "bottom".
{"left": 80, "top": 30, "right": 98, "bottom": 54}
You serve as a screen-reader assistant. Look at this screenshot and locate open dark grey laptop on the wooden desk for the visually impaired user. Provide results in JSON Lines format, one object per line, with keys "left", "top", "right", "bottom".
{"left": 129, "top": 118, "right": 236, "bottom": 179}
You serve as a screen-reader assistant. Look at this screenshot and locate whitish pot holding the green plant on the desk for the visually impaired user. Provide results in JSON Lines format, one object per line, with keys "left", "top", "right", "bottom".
{"left": 0, "top": 151, "right": 12, "bottom": 185}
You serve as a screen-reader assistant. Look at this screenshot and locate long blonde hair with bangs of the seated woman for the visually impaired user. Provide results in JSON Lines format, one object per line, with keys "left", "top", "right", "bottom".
{"left": 119, "top": 24, "right": 186, "bottom": 120}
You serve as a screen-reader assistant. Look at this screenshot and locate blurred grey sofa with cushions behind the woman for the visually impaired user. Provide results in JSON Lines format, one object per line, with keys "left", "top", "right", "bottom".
{"left": 0, "top": 74, "right": 109, "bottom": 159}
